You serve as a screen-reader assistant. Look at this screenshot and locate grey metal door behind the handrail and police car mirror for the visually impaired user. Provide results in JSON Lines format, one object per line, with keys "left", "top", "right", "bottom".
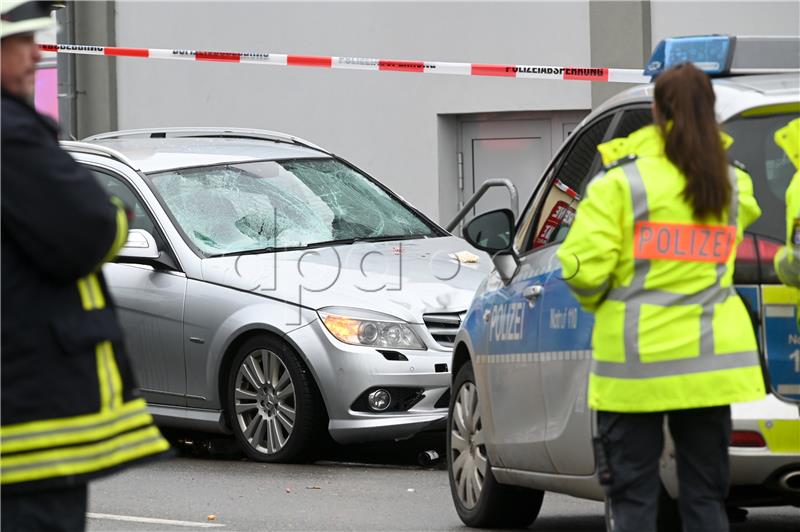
{"left": 461, "top": 118, "right": 560, "bottom": 218}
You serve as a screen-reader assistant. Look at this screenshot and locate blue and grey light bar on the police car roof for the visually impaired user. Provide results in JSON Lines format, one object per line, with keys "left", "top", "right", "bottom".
{"left": 644, "top": 35, "right": 800, "bottom": 77}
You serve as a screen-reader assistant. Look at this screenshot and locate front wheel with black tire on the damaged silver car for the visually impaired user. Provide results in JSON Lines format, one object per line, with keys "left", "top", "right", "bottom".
{"left": 225, "top": 335, "right": 326, "bottom": 462}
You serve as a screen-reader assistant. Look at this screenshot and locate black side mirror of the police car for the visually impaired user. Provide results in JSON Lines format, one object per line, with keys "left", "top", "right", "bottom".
{"left": 463, "top": 209, "right": 519, "bottom": 284}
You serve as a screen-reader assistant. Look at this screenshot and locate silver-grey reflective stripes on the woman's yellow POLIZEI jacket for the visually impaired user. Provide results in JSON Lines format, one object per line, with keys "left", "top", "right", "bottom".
{"left": 592, "top": 161, "right": 758, "bottom": 379}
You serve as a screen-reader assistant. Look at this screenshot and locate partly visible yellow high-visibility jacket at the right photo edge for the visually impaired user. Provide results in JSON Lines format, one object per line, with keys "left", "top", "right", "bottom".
{"left": 775, "top": 118, "right": 800, "bottom": 288}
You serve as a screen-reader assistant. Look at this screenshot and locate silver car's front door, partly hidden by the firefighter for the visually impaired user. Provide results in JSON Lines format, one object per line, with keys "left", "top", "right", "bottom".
{"left": 90, "top": 167, "right": 187, "bottom": 406}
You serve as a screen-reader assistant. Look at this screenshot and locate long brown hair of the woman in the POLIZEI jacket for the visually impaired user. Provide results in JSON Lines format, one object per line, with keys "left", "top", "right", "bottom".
{"left": 655, "top": 63, "right": 732, "bottom": 220}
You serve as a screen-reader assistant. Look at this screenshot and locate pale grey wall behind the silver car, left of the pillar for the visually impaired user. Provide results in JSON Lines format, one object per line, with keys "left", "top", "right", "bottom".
{"left": 116, "top": 1, "right": 591, "bottom": 220}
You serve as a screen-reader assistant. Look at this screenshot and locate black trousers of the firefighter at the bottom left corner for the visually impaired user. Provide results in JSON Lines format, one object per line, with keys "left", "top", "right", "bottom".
{"left": 0, "top": 484, "right": 87, "bottom": 532}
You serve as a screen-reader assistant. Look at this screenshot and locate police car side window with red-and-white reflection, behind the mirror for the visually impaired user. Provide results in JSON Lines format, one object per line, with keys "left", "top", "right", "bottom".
{"left": 520, "top": 115, "right": 613, "bottom": 253}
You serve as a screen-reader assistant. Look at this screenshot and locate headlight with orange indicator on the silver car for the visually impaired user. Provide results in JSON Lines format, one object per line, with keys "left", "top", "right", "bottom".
{"left": 318, "top": 307, "right": 425, "bottom": 349}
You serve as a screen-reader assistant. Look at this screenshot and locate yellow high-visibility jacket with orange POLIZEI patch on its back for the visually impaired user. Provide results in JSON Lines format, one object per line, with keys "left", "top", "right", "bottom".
{"left": 558, "top": 126, "right": 765, "bottom": 412}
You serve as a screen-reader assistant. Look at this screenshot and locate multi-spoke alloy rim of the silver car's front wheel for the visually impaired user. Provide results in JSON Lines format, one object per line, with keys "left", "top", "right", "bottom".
{"left": 234, "top": 349, "right": 297, "bottom": 454}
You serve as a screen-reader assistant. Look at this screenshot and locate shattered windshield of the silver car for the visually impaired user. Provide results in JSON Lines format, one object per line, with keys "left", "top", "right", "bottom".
{"left": 150, "top": 159, "right": 438, "bottom": 255}
